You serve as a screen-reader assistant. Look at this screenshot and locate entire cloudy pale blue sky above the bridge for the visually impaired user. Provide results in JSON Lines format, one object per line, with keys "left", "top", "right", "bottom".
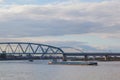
{"left": 0, "top": 0, "right": 120, "bottom": 52}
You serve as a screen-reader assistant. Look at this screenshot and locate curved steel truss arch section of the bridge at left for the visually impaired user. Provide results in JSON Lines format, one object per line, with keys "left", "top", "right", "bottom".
{"left": 0, "top": 42, "right": 64, "bottom": 57}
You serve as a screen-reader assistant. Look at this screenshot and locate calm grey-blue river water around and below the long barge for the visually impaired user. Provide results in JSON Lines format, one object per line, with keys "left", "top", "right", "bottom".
{"left": 0, "top": 61, "right": 120, "bottom": 80}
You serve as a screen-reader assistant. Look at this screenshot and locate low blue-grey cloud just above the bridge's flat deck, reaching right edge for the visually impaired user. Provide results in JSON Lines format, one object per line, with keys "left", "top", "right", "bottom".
{"left": 43, "top": 41, "right": 120, "bottom": 52}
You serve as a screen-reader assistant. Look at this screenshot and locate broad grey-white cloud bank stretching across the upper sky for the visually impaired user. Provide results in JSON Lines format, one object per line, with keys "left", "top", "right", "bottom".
{"left": 0, "top": 0, "right": 120, "bottom": 37}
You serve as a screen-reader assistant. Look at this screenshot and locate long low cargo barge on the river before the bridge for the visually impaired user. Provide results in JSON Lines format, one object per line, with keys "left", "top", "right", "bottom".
{"left": 48, "top": 61, "right": 98, "bottom": 65}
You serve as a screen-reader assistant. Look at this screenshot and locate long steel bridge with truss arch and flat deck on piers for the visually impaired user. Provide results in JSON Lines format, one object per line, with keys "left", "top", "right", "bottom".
{"left": 0, "top": 42, "right": 120, "bottom": 60}
